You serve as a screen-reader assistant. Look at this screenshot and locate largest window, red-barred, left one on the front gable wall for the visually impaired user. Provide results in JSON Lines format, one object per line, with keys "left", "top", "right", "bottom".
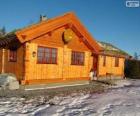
{"left": 37, "top": 47, "right": 57, "bottom": 64}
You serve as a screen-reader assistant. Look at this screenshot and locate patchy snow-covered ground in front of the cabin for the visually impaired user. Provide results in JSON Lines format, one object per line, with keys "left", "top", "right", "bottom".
{"left": 0, "top": 80, "right": 140, "bottom": 116}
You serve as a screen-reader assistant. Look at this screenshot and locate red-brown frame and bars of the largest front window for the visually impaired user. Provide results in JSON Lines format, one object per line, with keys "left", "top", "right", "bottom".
{"left": 37, "top": 46, "right": 58, "bottom": 64}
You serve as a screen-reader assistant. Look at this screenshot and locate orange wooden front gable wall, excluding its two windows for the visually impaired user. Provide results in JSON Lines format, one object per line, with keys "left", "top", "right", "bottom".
{"left": 25, "top": 27, "right": 93, "bottom": 82}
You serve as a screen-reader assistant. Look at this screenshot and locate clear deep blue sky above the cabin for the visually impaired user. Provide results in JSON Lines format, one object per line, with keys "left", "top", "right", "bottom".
{"left": 0, "top": 0, "right": 140, "bottom": 55}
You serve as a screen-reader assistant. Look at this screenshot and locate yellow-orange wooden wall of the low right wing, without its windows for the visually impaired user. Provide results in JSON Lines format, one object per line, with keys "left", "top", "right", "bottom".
{"left": 98, "top": 55, "right": 125, "bottom": 77}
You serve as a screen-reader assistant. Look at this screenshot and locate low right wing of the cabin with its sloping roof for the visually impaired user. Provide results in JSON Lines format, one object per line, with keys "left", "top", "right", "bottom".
{"left": 98, "top": 42, "right": 130, "bottom": 79}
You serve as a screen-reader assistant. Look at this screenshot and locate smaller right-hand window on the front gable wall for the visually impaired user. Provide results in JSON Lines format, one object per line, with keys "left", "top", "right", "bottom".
{"left": 71, "top": 51, "right": 85, "bottom": 65}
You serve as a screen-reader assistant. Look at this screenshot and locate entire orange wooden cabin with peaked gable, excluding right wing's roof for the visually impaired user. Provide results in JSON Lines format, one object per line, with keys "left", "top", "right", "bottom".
{"left": 0, "top": 13, "right": 128, "bottom": 84}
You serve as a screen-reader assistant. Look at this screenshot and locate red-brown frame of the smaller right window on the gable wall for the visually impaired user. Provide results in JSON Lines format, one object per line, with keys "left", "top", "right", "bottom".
{"left": 71, "top": 51, "right": 85, "bottom": 66}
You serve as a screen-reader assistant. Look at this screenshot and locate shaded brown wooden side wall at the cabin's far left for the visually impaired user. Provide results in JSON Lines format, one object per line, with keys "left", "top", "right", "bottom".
{"left": 0, "top": 46, "right": 24, "bottom": 80}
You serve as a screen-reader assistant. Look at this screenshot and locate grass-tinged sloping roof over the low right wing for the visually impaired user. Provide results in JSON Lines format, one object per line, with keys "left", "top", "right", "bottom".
{"left": 98, "top": 41, "right": 130, "bottom": 57}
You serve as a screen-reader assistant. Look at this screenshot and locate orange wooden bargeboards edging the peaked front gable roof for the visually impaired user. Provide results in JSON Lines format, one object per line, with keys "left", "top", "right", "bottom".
{"left": 15, "top": 13, "right": 102, "bottom": 53}
